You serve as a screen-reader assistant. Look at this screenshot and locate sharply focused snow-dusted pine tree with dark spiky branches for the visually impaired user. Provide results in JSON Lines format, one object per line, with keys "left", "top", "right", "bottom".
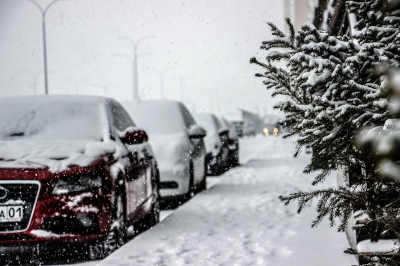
{"left": 251, "top": 0, "right": 400, "bottom": 262}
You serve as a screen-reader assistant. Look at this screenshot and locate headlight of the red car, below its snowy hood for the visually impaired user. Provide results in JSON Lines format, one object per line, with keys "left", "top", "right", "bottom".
{"left": 53, "top": 175, "right": 103, "bottom": 195}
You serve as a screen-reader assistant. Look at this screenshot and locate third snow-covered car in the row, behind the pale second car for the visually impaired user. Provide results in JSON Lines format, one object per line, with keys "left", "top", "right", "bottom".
{"left": 193, "top": 113, "right": 229, "bottom": 175}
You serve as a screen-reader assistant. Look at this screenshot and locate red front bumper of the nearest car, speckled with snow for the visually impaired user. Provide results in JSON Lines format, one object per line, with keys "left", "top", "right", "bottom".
{"left": 0, "top": 189, "right": 112, "bottom": 246}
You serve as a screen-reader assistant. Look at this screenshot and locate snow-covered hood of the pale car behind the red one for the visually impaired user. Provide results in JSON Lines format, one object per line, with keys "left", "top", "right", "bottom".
{"left": 150, "top": 133, "right": 191, "bottom": 172}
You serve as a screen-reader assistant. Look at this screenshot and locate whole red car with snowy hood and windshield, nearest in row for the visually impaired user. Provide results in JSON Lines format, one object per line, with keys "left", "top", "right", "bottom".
{"left": 0, "top": 96, "right": 160, "bottom": 258}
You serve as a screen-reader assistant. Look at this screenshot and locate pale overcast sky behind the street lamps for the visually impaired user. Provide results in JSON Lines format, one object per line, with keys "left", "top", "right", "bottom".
{"left": 0, "top": 0, "right": 284, "bottom": 114}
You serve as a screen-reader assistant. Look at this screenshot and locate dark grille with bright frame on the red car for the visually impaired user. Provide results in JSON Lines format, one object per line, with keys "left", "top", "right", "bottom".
{"left": 0, "top": 181, "right": 40, "bottom": 232}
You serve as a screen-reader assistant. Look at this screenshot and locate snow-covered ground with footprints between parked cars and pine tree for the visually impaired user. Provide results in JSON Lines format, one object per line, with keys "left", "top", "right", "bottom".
{"left": 49, "top": 136, "right": 357, "bottom": 266}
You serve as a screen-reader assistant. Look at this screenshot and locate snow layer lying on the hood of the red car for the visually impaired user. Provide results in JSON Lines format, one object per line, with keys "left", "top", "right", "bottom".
{"left": 0, "top": 140, "right": 116, "bottom": 173}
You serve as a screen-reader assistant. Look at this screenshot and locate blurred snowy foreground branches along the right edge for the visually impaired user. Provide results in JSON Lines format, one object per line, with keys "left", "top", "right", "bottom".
{"left": 354, "top": 69, "right": 400, "bottom": 265}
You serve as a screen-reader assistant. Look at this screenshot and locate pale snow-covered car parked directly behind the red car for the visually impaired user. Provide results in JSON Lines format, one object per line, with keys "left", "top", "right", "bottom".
{"left": 122, "top": 100, "right": 206, "bottom": 203}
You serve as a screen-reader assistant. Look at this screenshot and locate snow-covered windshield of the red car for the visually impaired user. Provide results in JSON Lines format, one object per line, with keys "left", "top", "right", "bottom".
{"left": 0, "top": 101, "right": 104, "bottom": 141}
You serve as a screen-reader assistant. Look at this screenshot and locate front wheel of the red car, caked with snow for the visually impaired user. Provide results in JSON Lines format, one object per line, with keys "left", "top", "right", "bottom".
{"left": 89, "top": 187, "right": 127, "bottom": 260}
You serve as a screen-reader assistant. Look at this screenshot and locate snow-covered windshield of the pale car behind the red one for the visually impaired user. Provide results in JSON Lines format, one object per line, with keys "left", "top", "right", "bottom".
{"left": 122, "top": 100, "right": 186, "bottom": 135}
